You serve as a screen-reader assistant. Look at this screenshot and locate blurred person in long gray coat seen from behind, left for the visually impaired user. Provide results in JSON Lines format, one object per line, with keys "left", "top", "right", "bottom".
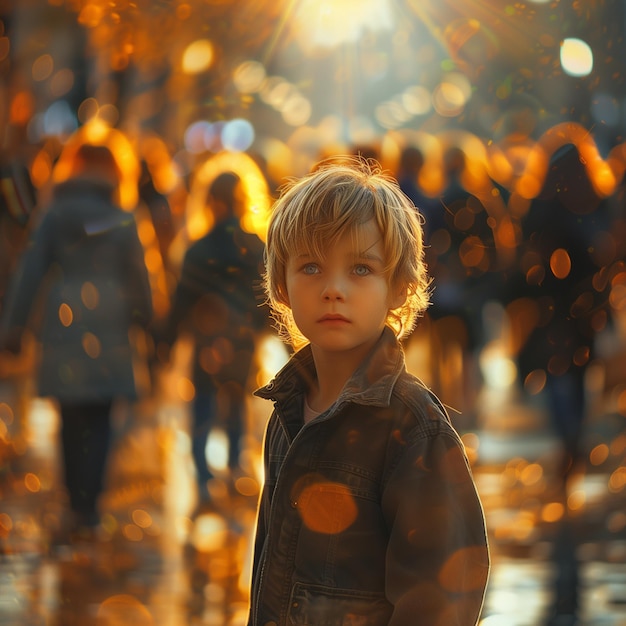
{"left": 0, "top": 145, "right": 152, "bottom": 530}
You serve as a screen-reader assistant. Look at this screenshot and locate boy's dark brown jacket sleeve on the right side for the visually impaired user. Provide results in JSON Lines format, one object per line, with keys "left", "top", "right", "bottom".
{"left": 382, "top": 432, "right": 489, "bottom": 626}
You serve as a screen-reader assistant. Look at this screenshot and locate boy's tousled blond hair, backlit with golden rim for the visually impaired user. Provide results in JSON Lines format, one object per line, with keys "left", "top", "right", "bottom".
{"left": 265, "top": 157, "right": 430, "bottom": 348}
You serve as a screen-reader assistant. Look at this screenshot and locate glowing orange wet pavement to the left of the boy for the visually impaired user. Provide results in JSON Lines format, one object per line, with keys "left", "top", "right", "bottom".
{"left": 0, "top": 390, "right": 258, "bottom": 626}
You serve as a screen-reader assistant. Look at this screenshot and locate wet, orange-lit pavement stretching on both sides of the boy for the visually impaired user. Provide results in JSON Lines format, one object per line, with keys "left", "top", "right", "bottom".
{"left": 0, "top": 332, "right": 626, "bottom": 626}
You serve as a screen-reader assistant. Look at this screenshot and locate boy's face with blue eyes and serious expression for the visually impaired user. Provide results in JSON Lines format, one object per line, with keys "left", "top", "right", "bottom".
{"left": 286, "top": 220, "right": 404, "bottom": 358}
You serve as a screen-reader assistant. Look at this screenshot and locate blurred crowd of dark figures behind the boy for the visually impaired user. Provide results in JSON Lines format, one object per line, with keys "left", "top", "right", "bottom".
{"left": 0, "top": 124, "right": 626, "bottom": 610}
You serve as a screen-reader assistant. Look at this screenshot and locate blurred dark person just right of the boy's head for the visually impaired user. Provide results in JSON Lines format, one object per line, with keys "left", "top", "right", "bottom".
{"left": 416, "top": 146, "right": 496, "bottom": 420}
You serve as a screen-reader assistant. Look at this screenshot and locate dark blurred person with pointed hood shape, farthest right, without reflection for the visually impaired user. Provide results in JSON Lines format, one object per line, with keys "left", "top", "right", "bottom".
{"left": 515, "top": 145, "right": 608, "bottom": 480}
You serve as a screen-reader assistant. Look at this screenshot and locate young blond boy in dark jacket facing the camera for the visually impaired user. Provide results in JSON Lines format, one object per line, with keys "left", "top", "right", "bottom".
{"left": 248, "top": 160, "right": 489, "bottom": 626}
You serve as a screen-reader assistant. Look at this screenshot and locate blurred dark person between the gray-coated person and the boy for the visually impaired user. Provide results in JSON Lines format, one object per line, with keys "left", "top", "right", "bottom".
{"left": 158, "top": 172, "right": 268, "bottom": 510}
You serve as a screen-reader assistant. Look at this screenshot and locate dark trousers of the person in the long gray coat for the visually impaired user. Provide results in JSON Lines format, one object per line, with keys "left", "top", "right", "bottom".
{"left": 59, "top": 401, "right": 112, "bottom": 526}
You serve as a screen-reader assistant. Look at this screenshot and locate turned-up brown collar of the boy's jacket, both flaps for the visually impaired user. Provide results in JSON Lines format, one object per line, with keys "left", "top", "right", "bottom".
{"left": 255, "top": 327, "right": 404, "bottom": 406}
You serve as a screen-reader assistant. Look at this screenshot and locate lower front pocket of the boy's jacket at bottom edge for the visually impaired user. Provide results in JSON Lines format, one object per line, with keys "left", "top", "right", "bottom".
{"left": 288, "top": 583, "right": 392, "bottom": 626}
